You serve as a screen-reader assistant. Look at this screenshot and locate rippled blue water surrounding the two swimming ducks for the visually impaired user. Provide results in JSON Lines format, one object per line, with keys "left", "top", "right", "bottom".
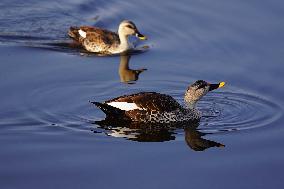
{"left": 0, "top": 0, "right": 284, "bottom": 188}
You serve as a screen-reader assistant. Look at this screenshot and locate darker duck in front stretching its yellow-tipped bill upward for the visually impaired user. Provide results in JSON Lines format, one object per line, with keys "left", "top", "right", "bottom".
{"left": 91, "top": 80, "right": 225, "bottom": 124}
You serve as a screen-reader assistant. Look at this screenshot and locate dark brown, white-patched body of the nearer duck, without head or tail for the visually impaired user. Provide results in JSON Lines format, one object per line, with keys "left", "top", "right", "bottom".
{"left": 105, "top": 92, "right": 199, "bottom": 123}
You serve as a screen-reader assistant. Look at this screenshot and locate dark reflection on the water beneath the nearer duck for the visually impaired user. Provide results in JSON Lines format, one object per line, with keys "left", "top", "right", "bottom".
{"left": 95, "top": 119, "right": 225, "bottom": 151}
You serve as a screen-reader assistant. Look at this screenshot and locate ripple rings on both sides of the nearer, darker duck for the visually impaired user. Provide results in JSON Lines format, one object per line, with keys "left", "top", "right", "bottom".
{"left": 23, "top": 78, "right": 282, "bottom": 133}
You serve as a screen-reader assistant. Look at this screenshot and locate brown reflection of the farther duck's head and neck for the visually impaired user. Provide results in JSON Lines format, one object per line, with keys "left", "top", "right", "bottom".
{"left": 118, "top": 54, "right": 147, "bottom": 84}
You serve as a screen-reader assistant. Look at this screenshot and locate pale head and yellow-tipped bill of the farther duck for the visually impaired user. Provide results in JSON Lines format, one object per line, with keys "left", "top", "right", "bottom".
{"left": 118, "top": 20, "right": 147, "bottom": 40}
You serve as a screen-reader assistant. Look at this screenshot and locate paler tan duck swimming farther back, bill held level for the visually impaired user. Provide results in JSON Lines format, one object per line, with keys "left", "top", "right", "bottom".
{"left": 68, "top": 20, "right": 147, "bottom": 54}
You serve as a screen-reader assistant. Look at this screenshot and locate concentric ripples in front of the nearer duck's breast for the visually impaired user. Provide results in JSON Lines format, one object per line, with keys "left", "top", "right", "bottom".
{"left": 199, "top": 92, "right": 282, "bottom": 132}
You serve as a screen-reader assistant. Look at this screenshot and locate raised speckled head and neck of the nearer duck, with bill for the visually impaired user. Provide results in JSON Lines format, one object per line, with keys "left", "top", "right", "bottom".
{"left": 184, "top": 80, "right": 225, "bottom": 108}
